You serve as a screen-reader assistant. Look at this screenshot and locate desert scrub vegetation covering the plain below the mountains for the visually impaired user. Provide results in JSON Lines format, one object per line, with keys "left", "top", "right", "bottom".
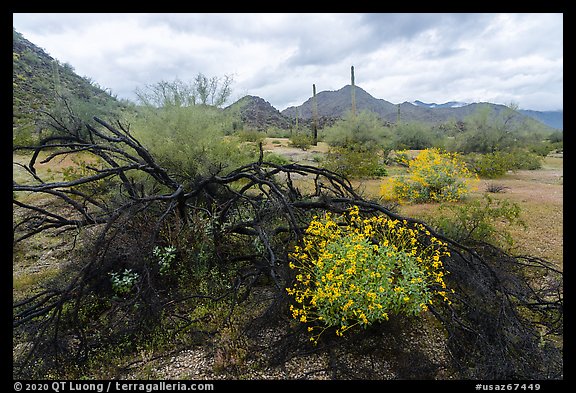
{"left": 13, "top": 78, "right": 563, "bottom": 379}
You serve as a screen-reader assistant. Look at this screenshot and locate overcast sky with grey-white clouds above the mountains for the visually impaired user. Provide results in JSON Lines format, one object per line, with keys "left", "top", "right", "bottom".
{"left": 13, "top": 13, "right": 564, "bottom": 110}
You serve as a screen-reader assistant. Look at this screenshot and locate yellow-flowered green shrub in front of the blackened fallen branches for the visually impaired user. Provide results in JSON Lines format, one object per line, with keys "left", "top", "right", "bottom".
{"left": 286, "top": 206, "right": 450, "bottom": 342}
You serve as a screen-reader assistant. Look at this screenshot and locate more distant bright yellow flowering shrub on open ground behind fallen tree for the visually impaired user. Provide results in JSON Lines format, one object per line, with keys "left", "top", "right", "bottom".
{"left": 380, "top": 148, "right": 478, "bottom": 203}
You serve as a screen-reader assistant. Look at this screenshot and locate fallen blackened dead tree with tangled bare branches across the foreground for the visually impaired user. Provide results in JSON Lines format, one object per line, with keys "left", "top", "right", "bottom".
{"left": 12, "top": 105, "right": 563, "bottom": 379}
